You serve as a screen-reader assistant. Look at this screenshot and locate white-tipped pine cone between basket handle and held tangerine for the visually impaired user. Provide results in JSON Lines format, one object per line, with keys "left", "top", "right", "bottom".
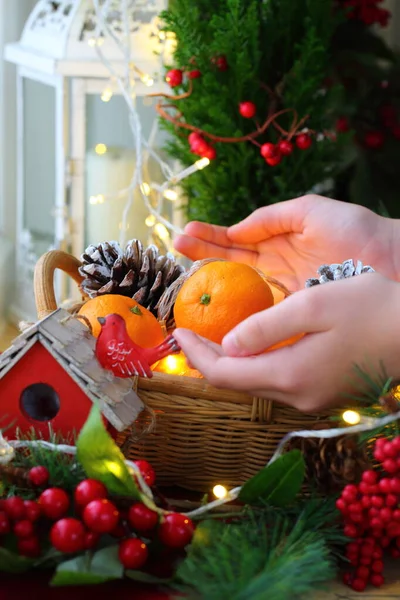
{"left": 79, "top": 240, "right": 185, "bottom": 326}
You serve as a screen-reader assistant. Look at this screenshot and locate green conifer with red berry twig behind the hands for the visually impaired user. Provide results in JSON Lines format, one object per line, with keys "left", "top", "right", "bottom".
{"left": 158, "top": 0, "right": 347, "bottom": 225}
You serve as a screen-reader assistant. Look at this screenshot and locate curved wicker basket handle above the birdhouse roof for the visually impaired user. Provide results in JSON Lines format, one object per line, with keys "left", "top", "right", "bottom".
{"left": 33, "top": 250, "right": 83, "bottom": 320}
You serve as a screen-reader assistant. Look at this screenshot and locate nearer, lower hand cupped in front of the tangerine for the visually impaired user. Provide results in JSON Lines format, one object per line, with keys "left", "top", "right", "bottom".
{"left": 174, "top": 273, "right": 400, "bottom": 412}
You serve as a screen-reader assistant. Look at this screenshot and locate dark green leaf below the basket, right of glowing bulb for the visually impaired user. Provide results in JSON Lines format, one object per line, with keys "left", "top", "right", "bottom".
{"left": 239, "top": 450, "right": 305, "bottom": 506}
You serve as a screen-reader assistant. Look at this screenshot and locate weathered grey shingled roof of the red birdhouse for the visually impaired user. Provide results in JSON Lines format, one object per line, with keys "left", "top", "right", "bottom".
{"left": 0, "top": 309, "right": 144, "bottom": 431}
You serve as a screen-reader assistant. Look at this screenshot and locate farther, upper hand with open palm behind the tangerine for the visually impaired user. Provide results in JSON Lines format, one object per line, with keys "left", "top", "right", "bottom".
{"left": 175, "top": 195, "right": 400, "bottom": 290}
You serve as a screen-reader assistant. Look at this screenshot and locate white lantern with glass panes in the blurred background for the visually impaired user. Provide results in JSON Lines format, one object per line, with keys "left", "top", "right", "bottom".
{"left": 5, "top": 0, "right": 173, "bottom": 319}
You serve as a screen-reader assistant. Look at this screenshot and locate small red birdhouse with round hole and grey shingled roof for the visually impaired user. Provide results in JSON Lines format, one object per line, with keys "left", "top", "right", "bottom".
{"left": 0, "top": 309, "right": 144, "bottom": 438}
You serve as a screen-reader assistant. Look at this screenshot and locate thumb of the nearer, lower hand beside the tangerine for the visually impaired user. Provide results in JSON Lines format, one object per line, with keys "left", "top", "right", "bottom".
{"left": 222, "top": 288, "right": 327, "bottom": 356}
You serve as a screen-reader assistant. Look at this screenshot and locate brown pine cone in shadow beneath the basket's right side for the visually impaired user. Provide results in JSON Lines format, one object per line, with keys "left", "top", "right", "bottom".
{"left": 289, "top": 428, "right": 368, "bottom": 494}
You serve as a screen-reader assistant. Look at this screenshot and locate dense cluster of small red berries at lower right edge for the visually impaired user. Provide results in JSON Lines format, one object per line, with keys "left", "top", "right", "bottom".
{"left": 336, "top": 436, "right": 400, "bottom": 592}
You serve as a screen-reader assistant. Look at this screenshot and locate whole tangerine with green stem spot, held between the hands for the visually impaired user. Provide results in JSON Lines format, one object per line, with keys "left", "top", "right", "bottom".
{"left": 174, "top": 261, "right": 274, "bottom": 344}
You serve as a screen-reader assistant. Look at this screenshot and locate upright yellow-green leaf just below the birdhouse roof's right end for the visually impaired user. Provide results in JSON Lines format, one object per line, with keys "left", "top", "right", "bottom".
{"left": 76, "top": 405, "right": 140, "bottom": 498}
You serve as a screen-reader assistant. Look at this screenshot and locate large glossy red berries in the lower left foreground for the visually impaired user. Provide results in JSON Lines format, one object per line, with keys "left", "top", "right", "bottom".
{"left": 0, "top": 460, "right": 194, "bottom": 569}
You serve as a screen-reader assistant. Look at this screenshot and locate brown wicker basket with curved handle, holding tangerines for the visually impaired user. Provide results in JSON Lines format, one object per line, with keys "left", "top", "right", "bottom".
{"left": 34, "top": 250, "right": 336, "bottom": 492}
